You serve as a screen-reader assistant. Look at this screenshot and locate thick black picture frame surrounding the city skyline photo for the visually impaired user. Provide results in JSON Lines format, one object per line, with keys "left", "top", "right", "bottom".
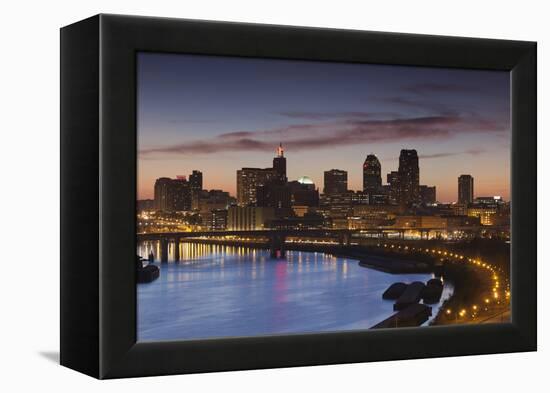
{"left": 61, "top": 15, "right": 537, "bottom": 379}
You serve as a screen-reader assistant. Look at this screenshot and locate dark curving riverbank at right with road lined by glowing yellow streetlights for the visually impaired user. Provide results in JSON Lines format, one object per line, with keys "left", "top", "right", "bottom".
{"left": 324, "top": 241, "right": 510, "bottom": 326}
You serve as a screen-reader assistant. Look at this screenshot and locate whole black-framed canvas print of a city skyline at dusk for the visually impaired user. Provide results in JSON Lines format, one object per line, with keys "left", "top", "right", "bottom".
{"left": 61, "top": 15, "right": 537, "bottom": 378}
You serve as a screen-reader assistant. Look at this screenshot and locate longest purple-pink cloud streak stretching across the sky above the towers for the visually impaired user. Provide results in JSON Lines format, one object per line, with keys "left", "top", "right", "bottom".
{"left": 140, "top": 115, "right": 508, "bottom": 158}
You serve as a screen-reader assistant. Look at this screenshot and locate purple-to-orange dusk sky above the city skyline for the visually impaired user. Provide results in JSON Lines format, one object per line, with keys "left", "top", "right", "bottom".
{"left": 138, "top": 53, "right": 511, "bottom": 202}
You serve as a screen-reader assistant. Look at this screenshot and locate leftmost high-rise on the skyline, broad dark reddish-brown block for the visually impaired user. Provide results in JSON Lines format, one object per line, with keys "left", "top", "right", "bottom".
{"left": 155, "top": 176, "right": 191, "bottom": 212}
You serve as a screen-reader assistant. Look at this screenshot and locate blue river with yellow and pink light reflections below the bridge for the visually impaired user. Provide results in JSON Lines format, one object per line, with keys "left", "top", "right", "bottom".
{"left": 137, "top": 242, "right": 453, "bottom": 341}
